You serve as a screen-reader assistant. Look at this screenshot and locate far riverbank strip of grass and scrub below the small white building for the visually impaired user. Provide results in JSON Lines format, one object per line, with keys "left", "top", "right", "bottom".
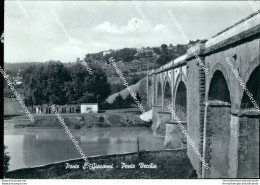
{"left": 5, "top": 110, "right": 151, "bottom": 129}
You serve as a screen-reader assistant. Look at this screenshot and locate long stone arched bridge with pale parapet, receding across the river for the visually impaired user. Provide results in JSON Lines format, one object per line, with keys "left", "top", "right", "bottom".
{"left": 147, "top": 13, "right": 260, "bottom": 178}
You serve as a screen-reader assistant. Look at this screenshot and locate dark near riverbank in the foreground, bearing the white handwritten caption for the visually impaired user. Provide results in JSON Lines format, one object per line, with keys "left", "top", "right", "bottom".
{"left": 5, "top": 149, "right": 197, "bottom": 179}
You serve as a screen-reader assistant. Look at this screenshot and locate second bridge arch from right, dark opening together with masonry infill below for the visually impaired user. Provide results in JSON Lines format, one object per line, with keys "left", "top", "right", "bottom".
{"left": 205, "top": 69, "right": 231, "bottom": 178}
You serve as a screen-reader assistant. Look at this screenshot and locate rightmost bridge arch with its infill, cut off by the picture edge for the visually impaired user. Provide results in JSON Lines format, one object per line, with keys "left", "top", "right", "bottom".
{"left": 238, "top": 64, "right": 260, "bottom": 178}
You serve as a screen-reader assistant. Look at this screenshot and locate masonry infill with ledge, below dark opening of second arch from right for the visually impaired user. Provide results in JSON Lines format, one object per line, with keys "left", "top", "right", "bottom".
{"left": 202, "top": 101, "right": 231, "bottom": 178}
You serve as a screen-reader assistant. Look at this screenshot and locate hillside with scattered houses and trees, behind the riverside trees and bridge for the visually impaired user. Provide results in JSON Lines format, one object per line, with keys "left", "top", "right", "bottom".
{"left": 4, "top": 41, "right": 198, "bottom": 105}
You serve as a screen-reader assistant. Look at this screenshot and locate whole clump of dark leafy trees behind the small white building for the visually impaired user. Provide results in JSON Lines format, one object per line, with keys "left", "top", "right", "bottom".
{"left": 23, "top": 61, "right": 111, "bottom": 105}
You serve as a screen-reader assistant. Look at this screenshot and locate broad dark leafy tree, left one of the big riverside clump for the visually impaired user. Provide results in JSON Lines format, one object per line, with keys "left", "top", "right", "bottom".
{"left": 23, "top": 61, "right": 71, "bottom": 105}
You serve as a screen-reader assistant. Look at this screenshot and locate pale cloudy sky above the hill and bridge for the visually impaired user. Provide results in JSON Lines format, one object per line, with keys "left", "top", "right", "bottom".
{"left": 4, "top": 1, "right": 259, "bottom": 62}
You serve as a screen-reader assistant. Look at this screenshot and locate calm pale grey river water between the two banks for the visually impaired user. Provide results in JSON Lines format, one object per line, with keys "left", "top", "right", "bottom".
{"left": 4, "top": 127, "right": 164, "bottom": 170}
